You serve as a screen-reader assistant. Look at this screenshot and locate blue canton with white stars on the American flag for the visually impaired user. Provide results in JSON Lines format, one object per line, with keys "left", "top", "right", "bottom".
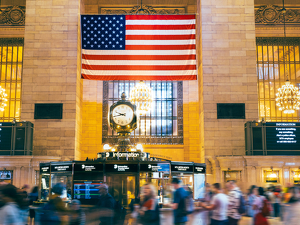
{"left": 81, "top": 15, "right": 125, "bottom": 50}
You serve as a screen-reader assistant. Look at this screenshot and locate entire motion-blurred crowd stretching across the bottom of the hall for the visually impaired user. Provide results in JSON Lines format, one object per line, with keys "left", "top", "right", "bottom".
{"left": 0, "top": 178, "right": 300, "bottom": 225}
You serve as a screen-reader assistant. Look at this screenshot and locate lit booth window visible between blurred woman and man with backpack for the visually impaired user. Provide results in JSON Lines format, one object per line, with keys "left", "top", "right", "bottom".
{"left": 140, "top": 172, "right": 170, "bottom": 204}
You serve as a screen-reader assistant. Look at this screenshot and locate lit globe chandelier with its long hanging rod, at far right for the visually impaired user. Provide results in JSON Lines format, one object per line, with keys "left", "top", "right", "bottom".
{"left": 275, "top": 0, "right": 300, "bottom": 114}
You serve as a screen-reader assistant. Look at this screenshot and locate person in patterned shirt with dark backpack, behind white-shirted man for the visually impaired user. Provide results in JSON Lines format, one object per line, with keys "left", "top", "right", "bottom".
{"left": 227, "top": 180, "right": 246, "bottom": 225}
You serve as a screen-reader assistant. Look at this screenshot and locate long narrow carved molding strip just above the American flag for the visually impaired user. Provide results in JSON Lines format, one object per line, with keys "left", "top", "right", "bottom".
{"left": 99, "top": 5, "right": 186, "bottom": 15}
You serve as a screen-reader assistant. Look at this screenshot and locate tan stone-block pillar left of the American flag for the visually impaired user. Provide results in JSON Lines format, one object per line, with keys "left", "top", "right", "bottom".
{"left": 21, "top": 0, "right": 80, "bottom": 160}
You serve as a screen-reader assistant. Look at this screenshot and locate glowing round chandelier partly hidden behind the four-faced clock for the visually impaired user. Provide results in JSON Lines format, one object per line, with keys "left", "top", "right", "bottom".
{"left": 129, "top": 81, "right": 153, "bottom": 114}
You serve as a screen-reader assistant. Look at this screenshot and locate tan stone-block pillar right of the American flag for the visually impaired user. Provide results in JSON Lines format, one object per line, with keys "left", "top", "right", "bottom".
{"left": 201, "top": 0, "right": 258, "bottom": 156}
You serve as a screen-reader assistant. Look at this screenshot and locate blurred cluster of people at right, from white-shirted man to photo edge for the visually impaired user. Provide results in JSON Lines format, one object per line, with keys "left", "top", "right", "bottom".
{"left": 200, "top": 181, "right": 300, "bottom": 225}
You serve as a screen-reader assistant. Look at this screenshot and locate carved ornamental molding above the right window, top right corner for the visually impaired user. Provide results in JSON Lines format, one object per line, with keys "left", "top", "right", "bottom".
{"left": 255, "top": 5, "right": 300, "bottom": 24}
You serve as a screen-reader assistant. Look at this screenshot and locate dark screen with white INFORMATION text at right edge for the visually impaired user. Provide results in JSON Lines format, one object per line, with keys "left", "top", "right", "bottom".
{"left": 266, "top": 122, "right": 300, "bottom": 150}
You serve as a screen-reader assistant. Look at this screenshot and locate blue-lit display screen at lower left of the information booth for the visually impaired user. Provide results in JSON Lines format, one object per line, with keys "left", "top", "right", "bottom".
{"left": 74, "top": 181, "right": 101, "bottom": 200}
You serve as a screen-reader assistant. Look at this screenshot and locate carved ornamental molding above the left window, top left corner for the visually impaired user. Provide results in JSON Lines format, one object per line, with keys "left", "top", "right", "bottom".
{"left": 0, "top": 6, "right": 25, "bottom": 26}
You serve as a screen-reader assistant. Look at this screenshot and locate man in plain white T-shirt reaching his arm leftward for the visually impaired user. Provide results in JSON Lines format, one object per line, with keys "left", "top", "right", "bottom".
{"left": 200, "top": 183, "right": 228, "bottom": 225}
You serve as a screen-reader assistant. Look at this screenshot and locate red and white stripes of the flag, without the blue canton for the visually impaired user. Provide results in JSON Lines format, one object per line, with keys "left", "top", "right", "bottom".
{"left": 82, "top": 15, "right": 197, "bottom": 80}
